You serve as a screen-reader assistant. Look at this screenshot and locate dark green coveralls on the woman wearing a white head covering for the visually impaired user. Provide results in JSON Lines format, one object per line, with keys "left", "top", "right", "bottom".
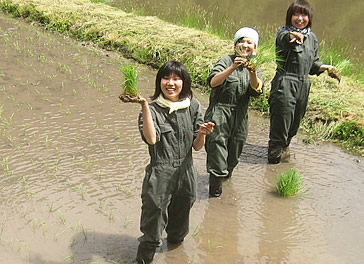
{"left": 205, "top": 55, "right": 263, "bottom": 177}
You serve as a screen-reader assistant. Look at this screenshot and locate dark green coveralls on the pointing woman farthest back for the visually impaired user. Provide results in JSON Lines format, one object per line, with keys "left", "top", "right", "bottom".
{"left": 268, "top": 30, "right": 323, "bottom": 162}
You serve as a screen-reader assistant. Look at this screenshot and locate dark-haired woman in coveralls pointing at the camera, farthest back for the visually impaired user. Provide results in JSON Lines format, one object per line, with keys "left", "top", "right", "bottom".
{"left": 268, "top": 0, "right": 334, "bottom": 164}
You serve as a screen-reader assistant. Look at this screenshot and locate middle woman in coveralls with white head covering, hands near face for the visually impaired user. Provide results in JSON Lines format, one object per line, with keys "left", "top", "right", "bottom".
{"left": 205, "top": 27, "right": 263, "bottom": 197}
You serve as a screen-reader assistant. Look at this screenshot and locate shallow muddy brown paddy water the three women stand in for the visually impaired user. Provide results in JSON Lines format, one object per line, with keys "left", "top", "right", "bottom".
{"left": 0, "top": 15, "right": 364, "bottom": 264}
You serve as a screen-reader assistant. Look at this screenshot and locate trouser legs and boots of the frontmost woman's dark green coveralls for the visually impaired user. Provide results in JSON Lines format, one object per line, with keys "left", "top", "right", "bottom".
{"left": 137, "top": 164, "right": 196, "bottom": 263}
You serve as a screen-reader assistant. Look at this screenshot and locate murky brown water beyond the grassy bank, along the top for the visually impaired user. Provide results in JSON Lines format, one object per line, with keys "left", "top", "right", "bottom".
{"left": 110, "top": 0, "right": 364, "bottom": 57}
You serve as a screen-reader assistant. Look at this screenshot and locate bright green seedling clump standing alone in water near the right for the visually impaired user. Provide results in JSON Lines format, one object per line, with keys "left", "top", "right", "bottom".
{"left": 276, "top": 168, "right": 302, "bottom": 197}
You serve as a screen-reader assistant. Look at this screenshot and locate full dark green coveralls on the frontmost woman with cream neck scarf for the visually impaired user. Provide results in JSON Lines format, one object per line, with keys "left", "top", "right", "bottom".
{"left": 137, "top": 98, "right": 203, "bottom": 263}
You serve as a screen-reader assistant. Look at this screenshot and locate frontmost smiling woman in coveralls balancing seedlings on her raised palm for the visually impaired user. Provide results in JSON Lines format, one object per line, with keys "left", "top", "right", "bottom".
{"left": 136, "top": 61, "right": 214, "bottom": 264}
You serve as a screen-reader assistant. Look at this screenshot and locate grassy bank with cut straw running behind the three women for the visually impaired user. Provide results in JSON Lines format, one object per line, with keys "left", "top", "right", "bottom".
{"left": 0, "top": 0, "right": 364, "bottom": 154}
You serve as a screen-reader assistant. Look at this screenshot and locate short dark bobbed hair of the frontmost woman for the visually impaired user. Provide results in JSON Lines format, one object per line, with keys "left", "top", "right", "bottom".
{"left": 151, "top": 61, "right": 193, "bottom": 100}
